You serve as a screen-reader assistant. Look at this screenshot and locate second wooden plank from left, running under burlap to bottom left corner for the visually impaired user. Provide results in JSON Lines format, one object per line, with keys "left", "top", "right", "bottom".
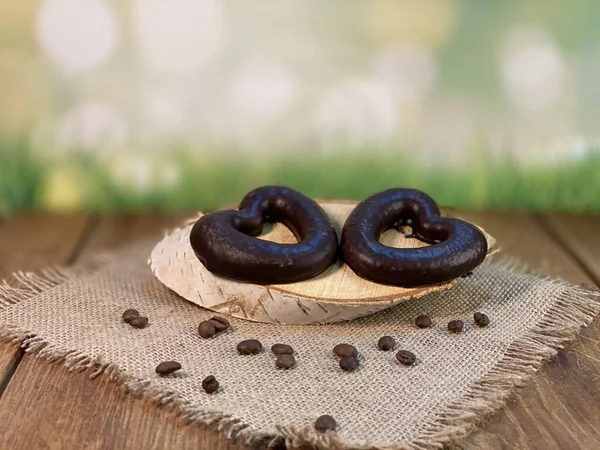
{"left": 0, "top": 215, "right": 244, "bottom": 449}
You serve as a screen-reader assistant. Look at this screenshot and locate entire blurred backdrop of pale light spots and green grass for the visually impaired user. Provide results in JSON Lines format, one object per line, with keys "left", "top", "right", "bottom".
{"left": 0, "top": 0, "right": 600, "bottom": 213}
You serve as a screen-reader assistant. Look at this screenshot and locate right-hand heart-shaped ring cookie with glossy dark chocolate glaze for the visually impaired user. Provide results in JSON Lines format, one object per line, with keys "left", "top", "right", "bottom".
{"left": 342, "top": 189, "right": 487, "bottom": 287}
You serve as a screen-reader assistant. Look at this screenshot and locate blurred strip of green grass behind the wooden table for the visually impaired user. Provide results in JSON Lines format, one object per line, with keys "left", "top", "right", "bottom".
{"left": 0, "top": 135, "right": 600, "bottom": 214}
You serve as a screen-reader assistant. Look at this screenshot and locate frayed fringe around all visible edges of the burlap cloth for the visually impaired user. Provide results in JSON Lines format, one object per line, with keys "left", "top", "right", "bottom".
{"left": 0, "top": 255, "right": 600, "bottom": 450}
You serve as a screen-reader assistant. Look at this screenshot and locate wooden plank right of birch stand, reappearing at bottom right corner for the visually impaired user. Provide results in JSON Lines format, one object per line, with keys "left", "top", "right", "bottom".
{"left": 456, "top": 214, "right": 600, "bottom": 450}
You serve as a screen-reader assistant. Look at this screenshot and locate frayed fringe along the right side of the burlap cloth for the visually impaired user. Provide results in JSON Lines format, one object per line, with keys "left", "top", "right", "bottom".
{"left": 277, "top": 259, "right": 600, "bottom": 450}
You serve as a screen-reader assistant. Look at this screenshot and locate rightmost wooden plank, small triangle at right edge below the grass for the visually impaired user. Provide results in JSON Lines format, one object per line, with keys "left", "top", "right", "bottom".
{"left": 542, "top": 214, "right": 600, "bottom": 286}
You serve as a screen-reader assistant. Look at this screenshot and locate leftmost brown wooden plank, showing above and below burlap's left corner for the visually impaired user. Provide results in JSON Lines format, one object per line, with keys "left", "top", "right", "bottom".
{"left": 0, "top": 214, "right": 90, "bottom": 395}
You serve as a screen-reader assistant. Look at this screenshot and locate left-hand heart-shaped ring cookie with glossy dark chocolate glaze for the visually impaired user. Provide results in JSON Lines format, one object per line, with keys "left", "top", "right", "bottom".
{"left": 190, "top": 186, "right": 339, "bottom": 284}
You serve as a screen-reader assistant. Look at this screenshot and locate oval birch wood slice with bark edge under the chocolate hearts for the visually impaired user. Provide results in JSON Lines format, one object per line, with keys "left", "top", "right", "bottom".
{"left": 148, "top": 201, "right": 498, "bottom": 325}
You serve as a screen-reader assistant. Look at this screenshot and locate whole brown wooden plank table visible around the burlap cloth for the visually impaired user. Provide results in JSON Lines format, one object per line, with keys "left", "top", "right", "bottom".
{"left": 0, "top": 213, "right": 600, "bottom": 450}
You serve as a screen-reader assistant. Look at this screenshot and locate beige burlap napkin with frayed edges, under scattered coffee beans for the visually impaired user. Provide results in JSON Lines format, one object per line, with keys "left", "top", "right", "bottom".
{"left": 0, "top": 242, "right": 600, "bottom": 449}
